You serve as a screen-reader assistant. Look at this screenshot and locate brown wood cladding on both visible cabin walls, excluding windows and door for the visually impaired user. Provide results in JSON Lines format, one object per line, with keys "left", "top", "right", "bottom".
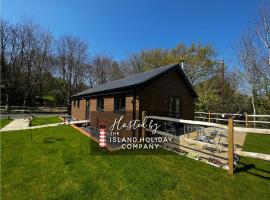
{"left": 71, "top": 66, "right": 195, "bottom": 136}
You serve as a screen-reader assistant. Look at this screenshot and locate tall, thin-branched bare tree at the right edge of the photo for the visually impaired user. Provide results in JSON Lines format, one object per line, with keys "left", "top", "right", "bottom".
{"left": 236, "top": 1, "right": 270, "bottom": 114}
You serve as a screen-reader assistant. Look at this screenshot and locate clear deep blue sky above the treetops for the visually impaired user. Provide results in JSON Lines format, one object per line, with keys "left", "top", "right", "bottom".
{"left": 1, "top": 0, "right": 258, "bottom": 67}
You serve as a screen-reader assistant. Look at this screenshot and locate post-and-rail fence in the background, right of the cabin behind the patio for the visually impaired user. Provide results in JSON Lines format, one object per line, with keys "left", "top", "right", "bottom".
{"left": 194, "top": 112, "right": 270, "bottom": 128}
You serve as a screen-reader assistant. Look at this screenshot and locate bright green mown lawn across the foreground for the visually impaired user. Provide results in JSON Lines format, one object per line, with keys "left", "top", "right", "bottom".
{"left": 1, "top": 125, "right": 270, "bottom": 200}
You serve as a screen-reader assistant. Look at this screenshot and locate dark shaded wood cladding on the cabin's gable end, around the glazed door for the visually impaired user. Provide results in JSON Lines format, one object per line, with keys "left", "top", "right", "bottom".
{"left": 140, "top": 68, "right": 194, "bottom": 119}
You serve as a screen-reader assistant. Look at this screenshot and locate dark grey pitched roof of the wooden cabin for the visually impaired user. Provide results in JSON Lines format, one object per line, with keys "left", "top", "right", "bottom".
{"left": 72, "top": 64, "right": 198, "bottom": 97}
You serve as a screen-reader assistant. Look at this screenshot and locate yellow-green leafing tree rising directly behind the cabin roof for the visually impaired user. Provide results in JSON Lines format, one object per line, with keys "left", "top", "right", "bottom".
{"left": 121, "top": 43, "right": 220, "bottom": 111}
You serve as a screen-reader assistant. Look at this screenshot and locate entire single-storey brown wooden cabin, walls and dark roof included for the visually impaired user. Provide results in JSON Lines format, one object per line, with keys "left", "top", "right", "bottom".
{"left": 71, "top": 64, "right": 197, "bottom": 136}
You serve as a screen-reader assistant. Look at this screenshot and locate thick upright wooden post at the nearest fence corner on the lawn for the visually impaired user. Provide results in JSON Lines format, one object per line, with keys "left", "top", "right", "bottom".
{"left": 228, "top": 118, "right": 234, "bottom": 175}
